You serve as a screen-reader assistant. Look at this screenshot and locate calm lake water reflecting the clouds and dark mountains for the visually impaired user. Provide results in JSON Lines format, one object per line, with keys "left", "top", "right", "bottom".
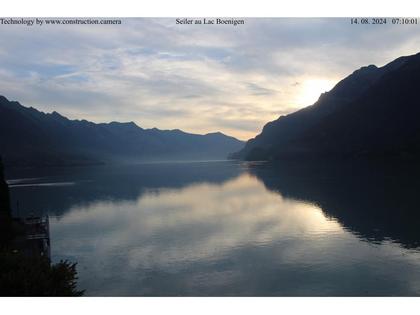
{"left": 7, "top": 162, "right": 420, "bottom": 296}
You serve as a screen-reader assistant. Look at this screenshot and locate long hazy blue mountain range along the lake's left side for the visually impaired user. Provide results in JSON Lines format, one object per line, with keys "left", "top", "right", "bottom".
{"left": 0, "top": 96, "right": 243, "bottom": 166}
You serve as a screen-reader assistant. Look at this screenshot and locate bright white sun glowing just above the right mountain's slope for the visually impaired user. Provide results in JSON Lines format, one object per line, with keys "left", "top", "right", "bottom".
{"left": 296, "top": 79, "right": 335, "bottom": 107}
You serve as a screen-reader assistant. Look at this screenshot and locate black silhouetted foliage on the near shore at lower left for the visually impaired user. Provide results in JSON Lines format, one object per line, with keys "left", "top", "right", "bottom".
{"left": 0, "top": 158, "right": 84, "bottom": 296}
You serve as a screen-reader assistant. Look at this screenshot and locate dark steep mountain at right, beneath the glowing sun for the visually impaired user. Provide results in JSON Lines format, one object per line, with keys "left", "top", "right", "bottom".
{"left": 232, "top": 53, "right": 420, "bottom": 160}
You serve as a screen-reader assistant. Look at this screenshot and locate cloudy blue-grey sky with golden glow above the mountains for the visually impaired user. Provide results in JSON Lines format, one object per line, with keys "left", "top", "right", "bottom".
{"left": 0, "top": 18, "right": 420, "bottom": 140}
